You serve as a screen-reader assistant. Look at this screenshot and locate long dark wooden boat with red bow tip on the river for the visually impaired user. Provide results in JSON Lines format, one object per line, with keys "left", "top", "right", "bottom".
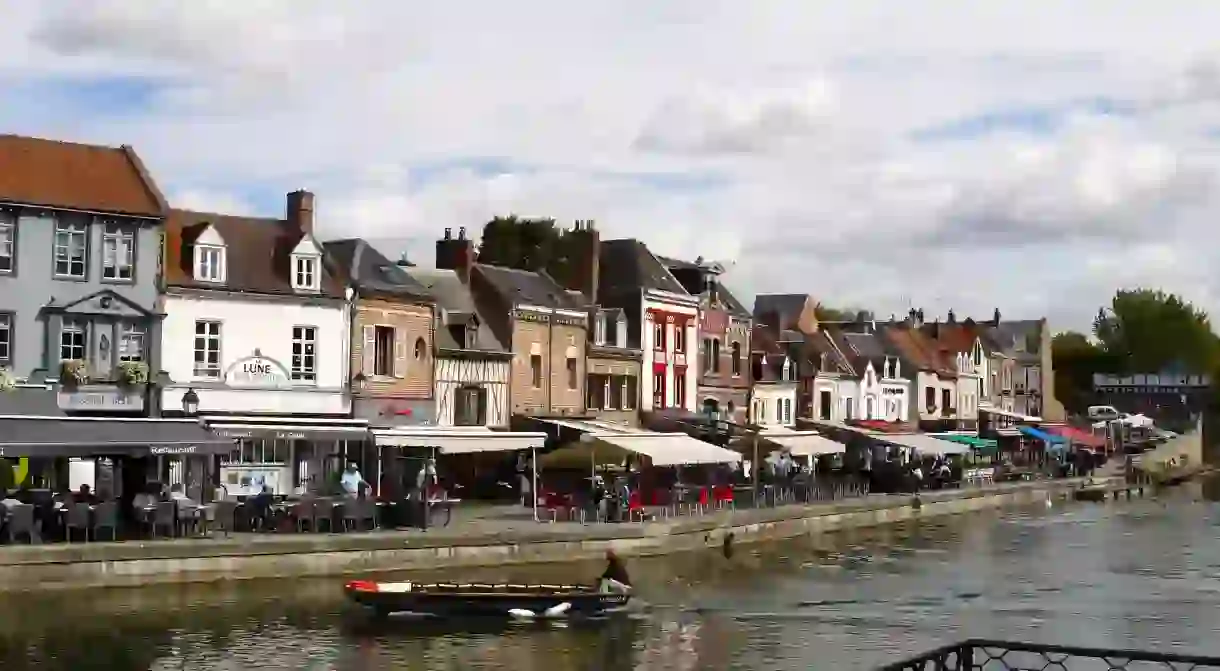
{"left": 344, "top": 581, "right": 631, "bottom": 620}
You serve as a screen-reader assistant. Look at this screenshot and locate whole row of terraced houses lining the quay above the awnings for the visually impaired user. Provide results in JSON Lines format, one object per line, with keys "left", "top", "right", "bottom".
{"left": 0, "top": 135, "right": 1061, "bottom": 493}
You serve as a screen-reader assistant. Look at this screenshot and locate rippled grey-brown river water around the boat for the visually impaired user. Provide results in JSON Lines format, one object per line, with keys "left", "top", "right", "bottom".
{"left": 0, "top": 488, "right": 1220, "bottom": 671}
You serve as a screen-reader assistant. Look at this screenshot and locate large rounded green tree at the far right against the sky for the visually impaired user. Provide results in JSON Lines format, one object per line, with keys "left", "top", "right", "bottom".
{"left": 1093, "top": 289, "right": 1220, "bottom": 373}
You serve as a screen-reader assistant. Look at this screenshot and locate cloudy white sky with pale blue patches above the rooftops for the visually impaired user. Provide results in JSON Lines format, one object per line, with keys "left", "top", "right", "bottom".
{"left": 0, "top": 0, "right": 1220, "bottom": 328}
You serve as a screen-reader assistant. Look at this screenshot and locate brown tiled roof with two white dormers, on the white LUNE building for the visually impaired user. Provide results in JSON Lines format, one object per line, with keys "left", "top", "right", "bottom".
{"left": 165, "top": 210, "right": 346, "bottom": 298}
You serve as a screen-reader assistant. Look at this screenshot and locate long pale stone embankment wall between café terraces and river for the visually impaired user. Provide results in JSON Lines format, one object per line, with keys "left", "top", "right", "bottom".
{"left": 0, "top": 478, "right": 1125, "bottom": 592}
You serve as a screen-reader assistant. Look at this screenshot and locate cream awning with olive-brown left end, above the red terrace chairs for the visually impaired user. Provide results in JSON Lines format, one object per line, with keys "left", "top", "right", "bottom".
{"left": 539, "top": 431, "right": 742, "bottom": 467}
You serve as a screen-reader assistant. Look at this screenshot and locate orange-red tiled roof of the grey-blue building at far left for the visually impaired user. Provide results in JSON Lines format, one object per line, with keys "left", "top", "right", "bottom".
{"left": 0, "top": 135, "right": 168, "bottom": 217}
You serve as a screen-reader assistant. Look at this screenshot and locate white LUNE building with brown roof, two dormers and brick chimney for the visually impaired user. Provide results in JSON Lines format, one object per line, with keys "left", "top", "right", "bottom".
{"left": 161, "top": 192, "right": 361, "bottom": 495}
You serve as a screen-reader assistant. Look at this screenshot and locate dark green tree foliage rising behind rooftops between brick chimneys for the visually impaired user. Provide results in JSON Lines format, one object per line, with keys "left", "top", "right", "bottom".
{"left": 478, "top": 215, "right": 576, "bottom": 285}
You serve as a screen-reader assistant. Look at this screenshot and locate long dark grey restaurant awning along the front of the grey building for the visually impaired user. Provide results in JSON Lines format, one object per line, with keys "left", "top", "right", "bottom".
{"left": 0, "top": 415, "right": 234, "bottom": 458}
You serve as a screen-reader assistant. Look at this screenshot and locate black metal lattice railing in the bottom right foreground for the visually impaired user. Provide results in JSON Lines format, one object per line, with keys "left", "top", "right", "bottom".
{"left": 878, "top": 639, "right": 1220, "bottom": 671}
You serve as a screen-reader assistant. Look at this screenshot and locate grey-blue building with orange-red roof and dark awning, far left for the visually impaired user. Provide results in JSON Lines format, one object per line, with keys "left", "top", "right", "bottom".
{"left": 0, "top": 135, "right": 228, "bottom": 495}
